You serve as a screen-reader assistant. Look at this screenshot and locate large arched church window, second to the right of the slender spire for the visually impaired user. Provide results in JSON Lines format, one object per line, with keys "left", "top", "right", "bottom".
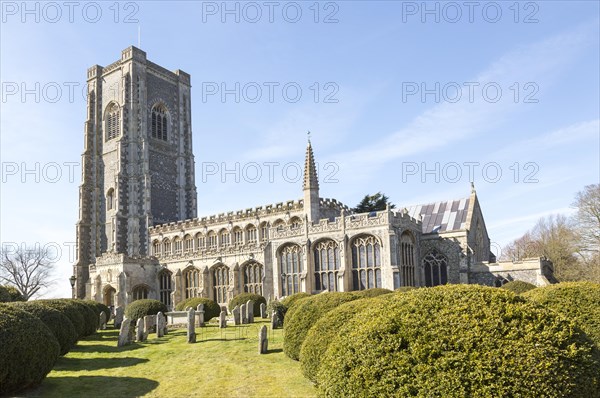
{"left": 351, "top": 235, "right": 381, "bottom": 290}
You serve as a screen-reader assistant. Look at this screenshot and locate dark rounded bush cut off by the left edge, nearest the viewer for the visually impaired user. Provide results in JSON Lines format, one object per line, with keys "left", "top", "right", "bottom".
{"left": 0, "top": 304, "right": 60, "bottom": 395}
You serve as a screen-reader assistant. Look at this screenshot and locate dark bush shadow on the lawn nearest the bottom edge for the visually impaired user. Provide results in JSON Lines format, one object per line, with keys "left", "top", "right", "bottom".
{"left": 25, "top": 376, "right": 159, "bottom": 398}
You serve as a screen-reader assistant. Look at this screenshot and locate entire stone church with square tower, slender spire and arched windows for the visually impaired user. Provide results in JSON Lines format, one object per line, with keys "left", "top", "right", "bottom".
{"left": 74, "top": 47, "right": 553, "bottom": 308}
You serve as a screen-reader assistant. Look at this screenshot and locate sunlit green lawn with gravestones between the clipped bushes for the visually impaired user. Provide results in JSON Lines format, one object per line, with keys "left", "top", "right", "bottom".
{"left": 23, "top": 320, "right": 315, "bottom": 398}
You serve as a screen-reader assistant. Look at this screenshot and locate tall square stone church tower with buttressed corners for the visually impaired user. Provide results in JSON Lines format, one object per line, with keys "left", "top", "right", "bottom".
{"left": 74, "top": 47, "right": 197, "bottom": 298}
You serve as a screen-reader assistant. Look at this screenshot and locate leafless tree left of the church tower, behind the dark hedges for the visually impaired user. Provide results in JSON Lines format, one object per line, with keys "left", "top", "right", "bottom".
{"left": 0, "top": 247, "right": 54, "bottom": 300}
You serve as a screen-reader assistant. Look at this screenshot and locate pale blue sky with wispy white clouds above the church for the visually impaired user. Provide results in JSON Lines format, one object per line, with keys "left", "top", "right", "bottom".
{"left": 0, "top": 1, "right": 600, "bottom": 296}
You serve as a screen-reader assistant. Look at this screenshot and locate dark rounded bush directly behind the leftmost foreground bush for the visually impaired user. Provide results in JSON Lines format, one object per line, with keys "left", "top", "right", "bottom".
{"left": 12, "top": 301, "right": 78, "bottom": 355}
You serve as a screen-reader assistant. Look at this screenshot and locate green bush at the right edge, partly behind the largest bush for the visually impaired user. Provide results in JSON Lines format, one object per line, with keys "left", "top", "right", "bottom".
{"left": 523, "top": 282, "right": 600, "bottom": 348}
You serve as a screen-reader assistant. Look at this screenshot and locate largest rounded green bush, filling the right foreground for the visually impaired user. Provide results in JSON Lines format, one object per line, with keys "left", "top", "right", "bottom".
{"left": 317, "top": 285, "right": 600, "bottom": 397}
